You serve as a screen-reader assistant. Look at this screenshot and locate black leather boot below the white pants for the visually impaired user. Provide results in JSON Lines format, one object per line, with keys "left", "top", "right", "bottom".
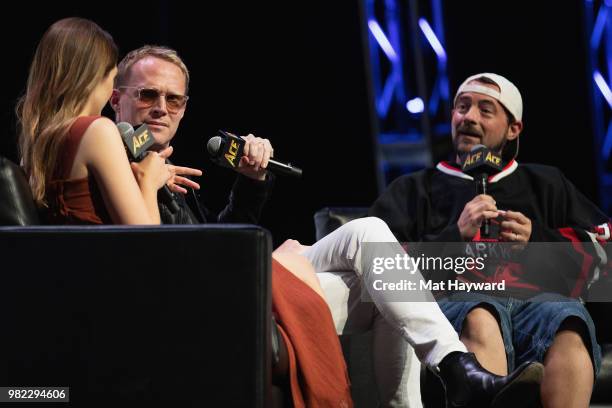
{"left": 438, "top": 352, "right": 544, "bottom": 408}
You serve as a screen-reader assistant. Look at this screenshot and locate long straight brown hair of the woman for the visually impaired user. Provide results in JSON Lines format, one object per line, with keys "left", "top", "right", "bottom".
{"left": 16, "top": 17, "right": 118, "bottom": 206}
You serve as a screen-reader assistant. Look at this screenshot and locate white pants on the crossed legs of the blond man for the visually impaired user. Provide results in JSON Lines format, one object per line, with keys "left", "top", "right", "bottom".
{"left": 304, "top": 217, "right": 467, "bottom": 408}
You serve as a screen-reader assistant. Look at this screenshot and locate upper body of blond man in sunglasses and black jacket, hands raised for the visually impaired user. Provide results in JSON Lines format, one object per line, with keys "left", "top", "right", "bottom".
{"left": 110, "top": 45, "right": 273, "bottom": 224}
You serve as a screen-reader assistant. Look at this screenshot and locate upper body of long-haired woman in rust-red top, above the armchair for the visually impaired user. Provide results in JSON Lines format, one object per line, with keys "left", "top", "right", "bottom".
{"left": 17, "top": 18, "right": 172, "bottom": 224}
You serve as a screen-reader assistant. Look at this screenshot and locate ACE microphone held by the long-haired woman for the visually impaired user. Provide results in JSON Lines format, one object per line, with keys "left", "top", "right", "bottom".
{"left": 117, "top": 122, "right": 179, "bottom": 213}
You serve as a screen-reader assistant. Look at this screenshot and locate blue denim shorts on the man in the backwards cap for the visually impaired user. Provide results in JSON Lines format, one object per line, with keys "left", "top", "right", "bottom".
{"left": 439, "top": 293, "right": 601, "bottom": 375}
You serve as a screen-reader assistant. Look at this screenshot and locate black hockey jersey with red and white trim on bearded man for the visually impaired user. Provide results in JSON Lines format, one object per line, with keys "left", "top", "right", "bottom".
{"left": 369, "top": 160, "right": 611, "bottom": 296}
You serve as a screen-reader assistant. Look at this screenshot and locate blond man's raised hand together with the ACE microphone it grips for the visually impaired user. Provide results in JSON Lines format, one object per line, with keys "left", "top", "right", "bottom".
{"left": 206, "top": 130, "right": 302, "bottom": 180}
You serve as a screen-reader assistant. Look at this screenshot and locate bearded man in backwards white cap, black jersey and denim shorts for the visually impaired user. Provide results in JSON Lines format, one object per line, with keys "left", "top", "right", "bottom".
{"left": 370, "top": 73, "right": 610, "bottom": 407}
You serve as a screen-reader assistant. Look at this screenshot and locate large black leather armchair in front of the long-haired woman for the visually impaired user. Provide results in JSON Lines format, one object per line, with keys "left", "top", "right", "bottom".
{"left": 0, "top": 158, "right": 287, "bottom": 408}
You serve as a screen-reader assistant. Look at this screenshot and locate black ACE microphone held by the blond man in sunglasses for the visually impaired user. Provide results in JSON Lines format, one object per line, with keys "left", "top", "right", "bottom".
{"left": 206, "top": 130, "right": 302, "bottom": 177}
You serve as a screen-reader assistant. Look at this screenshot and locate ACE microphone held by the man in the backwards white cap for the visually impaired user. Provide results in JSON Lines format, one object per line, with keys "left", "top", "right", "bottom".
{"left": 461, "top": 144, "right": 502, "bottom": 238}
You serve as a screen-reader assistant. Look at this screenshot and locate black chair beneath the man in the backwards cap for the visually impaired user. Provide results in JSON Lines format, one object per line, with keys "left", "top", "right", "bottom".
{"left": 314, "top": 207, "right": 612, "bottom": 408}
